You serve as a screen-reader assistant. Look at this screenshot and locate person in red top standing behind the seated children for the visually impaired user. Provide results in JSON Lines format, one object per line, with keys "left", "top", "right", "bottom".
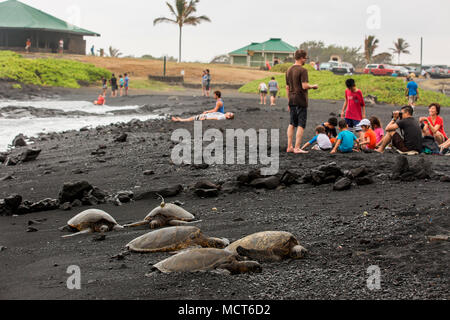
{"left": 341, "top": 79, "right": 366, "bottom": 128}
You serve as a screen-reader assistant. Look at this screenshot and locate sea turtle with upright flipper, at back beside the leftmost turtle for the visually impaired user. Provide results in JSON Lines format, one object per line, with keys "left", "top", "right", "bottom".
{"left": 125, "top": 197, "right": 201, "bottom": 229}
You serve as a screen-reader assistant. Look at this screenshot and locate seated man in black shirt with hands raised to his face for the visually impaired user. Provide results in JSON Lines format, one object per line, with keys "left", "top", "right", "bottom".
{"left": 376, "top": 106, "right": 423, "bottom": 155}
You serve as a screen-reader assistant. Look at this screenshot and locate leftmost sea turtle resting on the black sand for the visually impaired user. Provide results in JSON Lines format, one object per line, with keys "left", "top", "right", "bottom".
{"left": 60, "top": 209, "right": 123, "bottom": 238}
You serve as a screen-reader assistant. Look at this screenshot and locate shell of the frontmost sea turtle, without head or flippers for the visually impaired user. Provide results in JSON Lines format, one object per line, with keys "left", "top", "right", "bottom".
{"left": 154, "top": 248, "right": 235, "bottom": 273}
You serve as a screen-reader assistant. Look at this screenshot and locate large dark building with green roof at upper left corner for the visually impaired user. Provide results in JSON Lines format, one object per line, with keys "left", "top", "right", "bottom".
{"left": 0, "top": 0, "right": 100, "bottom": 54}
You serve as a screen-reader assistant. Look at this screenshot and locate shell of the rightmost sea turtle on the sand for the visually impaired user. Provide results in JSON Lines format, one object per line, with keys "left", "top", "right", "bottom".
{"left": 225, "top": 231, "right": 298, "bottom": 256}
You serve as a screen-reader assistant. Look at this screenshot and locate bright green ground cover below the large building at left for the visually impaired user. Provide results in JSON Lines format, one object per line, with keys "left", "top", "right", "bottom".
{"left": 0, "top": 51, "right": 111, "bottom": 88}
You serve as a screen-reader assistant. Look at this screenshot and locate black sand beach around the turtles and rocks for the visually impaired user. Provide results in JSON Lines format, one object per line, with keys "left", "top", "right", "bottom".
{"left": 0, "top": 90, "right": 450, "bottom": 300}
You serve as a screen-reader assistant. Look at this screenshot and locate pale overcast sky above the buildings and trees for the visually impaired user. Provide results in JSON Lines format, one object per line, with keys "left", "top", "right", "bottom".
{"left": 22, "top": 0, "right": 450, "bottom": 64}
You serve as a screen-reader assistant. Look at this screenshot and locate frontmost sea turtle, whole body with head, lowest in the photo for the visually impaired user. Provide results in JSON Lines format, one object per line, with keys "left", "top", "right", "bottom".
{"left": 149, "top": 248, "right": 262, "bottom": 274}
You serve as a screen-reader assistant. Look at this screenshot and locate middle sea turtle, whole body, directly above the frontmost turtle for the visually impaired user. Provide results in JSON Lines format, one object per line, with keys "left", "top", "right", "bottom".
{"left": 126, "top": 226, "right": 230, "bottom": 253}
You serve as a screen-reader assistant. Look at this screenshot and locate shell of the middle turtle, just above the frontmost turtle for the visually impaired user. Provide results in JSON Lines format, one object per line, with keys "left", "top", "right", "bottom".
{"left": 126, "top": 227, "right": 202, "bottom": 253}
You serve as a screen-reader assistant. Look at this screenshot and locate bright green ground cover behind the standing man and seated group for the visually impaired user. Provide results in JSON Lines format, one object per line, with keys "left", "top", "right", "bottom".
{"left": 239, "top": 65, "right": 450, "bottom": 106}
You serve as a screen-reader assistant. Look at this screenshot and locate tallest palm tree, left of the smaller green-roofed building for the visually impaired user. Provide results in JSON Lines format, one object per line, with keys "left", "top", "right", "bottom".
{"left": 153, "top": 0, "right": 211, "bottom": 62}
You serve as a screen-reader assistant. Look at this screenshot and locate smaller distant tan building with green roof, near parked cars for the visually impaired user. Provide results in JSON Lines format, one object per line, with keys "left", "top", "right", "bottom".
{"left": 229, "top": 38, "right": 298, "bottom": 67}
